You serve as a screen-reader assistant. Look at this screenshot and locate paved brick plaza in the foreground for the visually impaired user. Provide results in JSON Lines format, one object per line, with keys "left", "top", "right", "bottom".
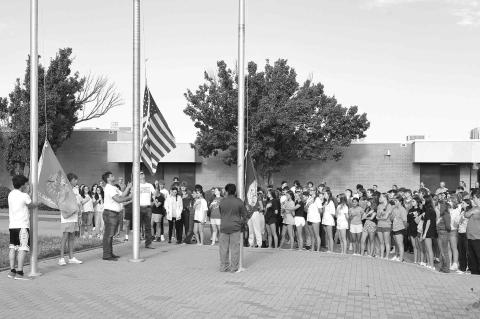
{"left": 0, "top": 243, "right": 480, "bottom": 318}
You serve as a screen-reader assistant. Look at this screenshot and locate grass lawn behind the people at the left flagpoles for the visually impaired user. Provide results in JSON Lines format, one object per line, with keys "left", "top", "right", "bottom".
{"left": 0, "top": 233, "right": 102, "bottom": 270}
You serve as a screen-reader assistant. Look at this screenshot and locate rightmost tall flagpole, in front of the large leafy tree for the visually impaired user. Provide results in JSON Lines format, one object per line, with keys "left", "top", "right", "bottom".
{"left": 237, "top": 0, "right": 245, "bottom": 271}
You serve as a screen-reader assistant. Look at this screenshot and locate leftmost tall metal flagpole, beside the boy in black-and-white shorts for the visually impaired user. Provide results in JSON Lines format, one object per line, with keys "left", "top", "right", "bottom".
{"left": 29, "top": 0, "right": 40, "bottom": 277}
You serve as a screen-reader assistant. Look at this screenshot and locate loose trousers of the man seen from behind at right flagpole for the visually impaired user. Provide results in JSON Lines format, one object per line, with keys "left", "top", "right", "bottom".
{"left": 218, "top": 232, "right": 241, "bottom": 271}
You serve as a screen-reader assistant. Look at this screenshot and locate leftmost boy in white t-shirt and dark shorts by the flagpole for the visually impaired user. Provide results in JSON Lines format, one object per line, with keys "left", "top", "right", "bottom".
{"left": 8, "top": 175, "right": 33, "bottom": 280}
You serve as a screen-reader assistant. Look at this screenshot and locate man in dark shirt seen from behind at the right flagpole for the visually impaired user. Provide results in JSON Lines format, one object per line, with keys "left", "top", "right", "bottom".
{"left": 219, "top": 184, "right": 247, "bottom": 272}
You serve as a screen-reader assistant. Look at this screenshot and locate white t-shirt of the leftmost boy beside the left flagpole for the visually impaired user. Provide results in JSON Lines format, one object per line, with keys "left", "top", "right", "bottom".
{"left": 8, "top": 189, "right": 32, "bottom": 229}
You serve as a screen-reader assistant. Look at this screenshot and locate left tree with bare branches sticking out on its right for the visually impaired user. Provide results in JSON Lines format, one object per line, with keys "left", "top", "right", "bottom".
{"left": 0, "top": 48, "right": 122, "bottom": 174}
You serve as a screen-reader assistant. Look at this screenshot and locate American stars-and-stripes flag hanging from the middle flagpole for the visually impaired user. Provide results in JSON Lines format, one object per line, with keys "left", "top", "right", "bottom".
{"left": 141, "top": 87, "right": 176, "bottom": 174}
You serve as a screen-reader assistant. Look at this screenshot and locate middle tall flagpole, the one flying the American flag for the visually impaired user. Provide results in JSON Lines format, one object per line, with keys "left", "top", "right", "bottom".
{"left": 130, "top": 0, "right": 143, "bottom": 262}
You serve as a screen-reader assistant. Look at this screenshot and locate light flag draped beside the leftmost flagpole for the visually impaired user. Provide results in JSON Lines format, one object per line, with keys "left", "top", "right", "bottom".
{"left": 38, "top": 141, "right": 78, "bottom": 214}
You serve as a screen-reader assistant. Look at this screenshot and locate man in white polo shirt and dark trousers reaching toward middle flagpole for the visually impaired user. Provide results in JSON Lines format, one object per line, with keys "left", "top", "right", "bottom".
{"left": 102, "top": 172, "right": 132, "bottom": 261}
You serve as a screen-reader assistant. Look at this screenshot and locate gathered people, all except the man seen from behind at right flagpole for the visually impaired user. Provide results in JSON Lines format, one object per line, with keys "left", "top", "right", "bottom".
{"left": 9, "top": 172, "right": 480, "bottom": 279}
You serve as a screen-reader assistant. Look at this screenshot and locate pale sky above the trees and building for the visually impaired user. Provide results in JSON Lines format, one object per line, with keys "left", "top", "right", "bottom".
{"left": 0, "top": 0, "right": 480, "bottom": 142}
